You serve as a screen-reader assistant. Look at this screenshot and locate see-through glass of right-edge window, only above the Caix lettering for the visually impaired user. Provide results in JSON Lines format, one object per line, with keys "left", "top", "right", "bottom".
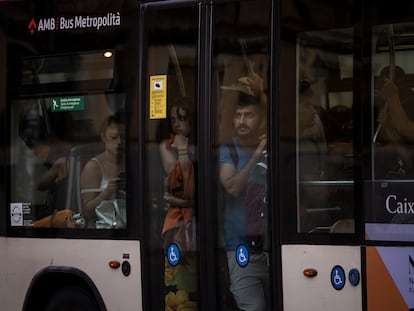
{"left": 373, "top": 24, "right": 414, "bottom": 179}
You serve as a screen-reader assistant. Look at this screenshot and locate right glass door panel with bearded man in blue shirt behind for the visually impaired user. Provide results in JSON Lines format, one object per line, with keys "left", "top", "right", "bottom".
{"left": 212, "top": 1, "right": 271, "bottom": 310}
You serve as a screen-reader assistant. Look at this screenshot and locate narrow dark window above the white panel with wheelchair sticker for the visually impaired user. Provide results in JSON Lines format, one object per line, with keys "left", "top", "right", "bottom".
{"left": 296, "top": 29, "right": 354, "bottom": 233}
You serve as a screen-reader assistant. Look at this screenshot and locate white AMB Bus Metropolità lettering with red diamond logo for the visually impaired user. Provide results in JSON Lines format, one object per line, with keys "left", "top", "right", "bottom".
{"left": 27, "top": 12, "right": 121, "bottom": 34}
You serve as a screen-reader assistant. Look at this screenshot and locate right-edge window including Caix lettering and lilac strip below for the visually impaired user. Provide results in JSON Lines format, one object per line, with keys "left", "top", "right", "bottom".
{"left": 365, "top": 23, "right": 414, "bottom": 241}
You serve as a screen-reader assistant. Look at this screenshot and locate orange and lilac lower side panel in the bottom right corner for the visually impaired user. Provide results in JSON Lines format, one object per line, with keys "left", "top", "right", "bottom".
{"left": 366, "top": 246, "right": 414, "bottom": 311}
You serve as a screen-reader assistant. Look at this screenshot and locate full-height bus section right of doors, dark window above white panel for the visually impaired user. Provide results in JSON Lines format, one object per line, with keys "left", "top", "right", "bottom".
{"left": 276, "top": 0, "right": 363, "bottom": 310}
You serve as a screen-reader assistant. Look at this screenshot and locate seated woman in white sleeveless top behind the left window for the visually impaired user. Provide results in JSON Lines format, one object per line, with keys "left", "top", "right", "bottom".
{"left": 80, "top": 112, "right": 127, "bottom": 229}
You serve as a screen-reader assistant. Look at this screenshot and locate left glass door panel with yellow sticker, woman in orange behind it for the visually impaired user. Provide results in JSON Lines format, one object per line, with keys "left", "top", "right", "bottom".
{"left": 144, "top": 7, "right": 199, "bottom": 310}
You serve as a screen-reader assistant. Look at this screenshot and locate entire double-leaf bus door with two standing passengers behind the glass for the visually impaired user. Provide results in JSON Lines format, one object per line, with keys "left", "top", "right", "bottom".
{"left": 140, "top": 0, "right": 279, "bottom": 311}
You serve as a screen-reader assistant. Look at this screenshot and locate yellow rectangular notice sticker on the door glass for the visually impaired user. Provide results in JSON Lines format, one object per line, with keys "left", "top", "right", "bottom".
{"left": 150, "top": 75, "right": 167, "bottom": 119}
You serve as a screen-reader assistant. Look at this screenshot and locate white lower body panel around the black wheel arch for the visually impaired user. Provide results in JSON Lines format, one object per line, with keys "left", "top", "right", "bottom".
{"left": 0, "top": 238, "right": 142, "bottom": 311}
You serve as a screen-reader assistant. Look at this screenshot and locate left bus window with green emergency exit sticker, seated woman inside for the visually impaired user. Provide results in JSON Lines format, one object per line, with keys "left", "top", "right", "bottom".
{"left": 10, "top": 93, "right": 126, "bottom": 228}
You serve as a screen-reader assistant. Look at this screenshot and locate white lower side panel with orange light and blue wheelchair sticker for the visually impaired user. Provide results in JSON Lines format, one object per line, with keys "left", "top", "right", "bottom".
{"left": 282, "top": 245, "right": 362, "bottom": 311}
